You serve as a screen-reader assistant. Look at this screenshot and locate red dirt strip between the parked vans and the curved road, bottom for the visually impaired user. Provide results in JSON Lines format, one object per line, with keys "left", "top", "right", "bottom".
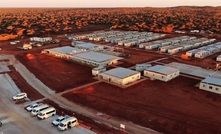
{"left": 42, "top": 99, "right": 125, "bottom": 134}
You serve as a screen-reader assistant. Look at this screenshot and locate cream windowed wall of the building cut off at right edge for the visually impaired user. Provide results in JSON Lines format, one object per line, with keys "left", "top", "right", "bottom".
{"left": 200, "top": 82, "right": 221, "bottom": 94}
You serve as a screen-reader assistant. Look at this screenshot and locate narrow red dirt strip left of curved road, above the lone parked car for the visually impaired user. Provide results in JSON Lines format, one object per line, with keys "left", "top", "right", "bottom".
{"left": 8, "top": 65, "right": 44, "bottom": 100}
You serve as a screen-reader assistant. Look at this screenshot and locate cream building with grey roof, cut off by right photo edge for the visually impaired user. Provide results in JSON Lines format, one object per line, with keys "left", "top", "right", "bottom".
{"left": 199, "top": 77, "right": 221, "bottom": 94}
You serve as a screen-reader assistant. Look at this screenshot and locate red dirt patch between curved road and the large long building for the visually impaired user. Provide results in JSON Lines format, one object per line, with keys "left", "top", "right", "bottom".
{"left": 16, "top": 54, "right": 96, "bottom": 92}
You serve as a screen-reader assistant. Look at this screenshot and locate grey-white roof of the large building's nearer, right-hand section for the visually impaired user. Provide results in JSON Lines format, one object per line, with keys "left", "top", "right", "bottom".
{"left": 74, "top": 52, "right": 123, "bottom": 62}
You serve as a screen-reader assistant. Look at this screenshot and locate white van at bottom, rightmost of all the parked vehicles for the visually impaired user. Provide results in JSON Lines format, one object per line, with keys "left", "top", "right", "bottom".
{"left": 58, "top": 117, "right": 78, "bottom": 131}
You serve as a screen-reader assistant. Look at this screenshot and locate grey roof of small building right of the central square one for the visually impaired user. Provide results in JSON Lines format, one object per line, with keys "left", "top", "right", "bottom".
{"left": 145, "top": 65, "right": 179, "bottom": 75}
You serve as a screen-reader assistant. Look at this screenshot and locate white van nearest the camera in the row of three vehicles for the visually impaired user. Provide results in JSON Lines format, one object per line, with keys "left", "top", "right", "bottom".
{"left": 38, "top": 107, "right": 56, "bottom": 120}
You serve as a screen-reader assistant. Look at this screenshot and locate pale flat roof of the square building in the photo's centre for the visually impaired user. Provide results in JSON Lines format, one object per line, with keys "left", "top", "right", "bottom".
{"left": 102, "top": 67, "right": 140, "bottom": 79}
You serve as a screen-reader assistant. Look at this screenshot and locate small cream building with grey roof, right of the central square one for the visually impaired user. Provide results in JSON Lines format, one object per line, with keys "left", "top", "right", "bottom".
{"left": 144, "top": 65, "right": 180, "bottom": 82}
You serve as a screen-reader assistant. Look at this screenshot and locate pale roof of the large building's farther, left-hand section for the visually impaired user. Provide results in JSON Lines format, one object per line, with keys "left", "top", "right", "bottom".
{"left": 46, "top": 46, "right": 82, "bottom": 54}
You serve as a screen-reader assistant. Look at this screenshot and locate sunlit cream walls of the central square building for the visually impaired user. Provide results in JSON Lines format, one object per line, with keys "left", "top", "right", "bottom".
{"left": 98, "top": 73, "right": 140, "bottom": 85}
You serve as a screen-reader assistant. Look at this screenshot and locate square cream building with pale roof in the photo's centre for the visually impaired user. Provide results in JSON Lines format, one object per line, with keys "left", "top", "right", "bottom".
{"left": 98, "top": 67, "right": 141, "bottom": 86}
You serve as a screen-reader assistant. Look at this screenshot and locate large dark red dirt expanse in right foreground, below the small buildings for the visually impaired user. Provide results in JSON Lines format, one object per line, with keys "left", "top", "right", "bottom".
{"left": 63, "top": 76, "right": 221, "bottom": 134}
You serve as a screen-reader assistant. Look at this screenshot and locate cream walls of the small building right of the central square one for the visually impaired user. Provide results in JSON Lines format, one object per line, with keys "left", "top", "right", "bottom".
{"left": 144, "top": 70, "right": 180, "bottom": 82}
